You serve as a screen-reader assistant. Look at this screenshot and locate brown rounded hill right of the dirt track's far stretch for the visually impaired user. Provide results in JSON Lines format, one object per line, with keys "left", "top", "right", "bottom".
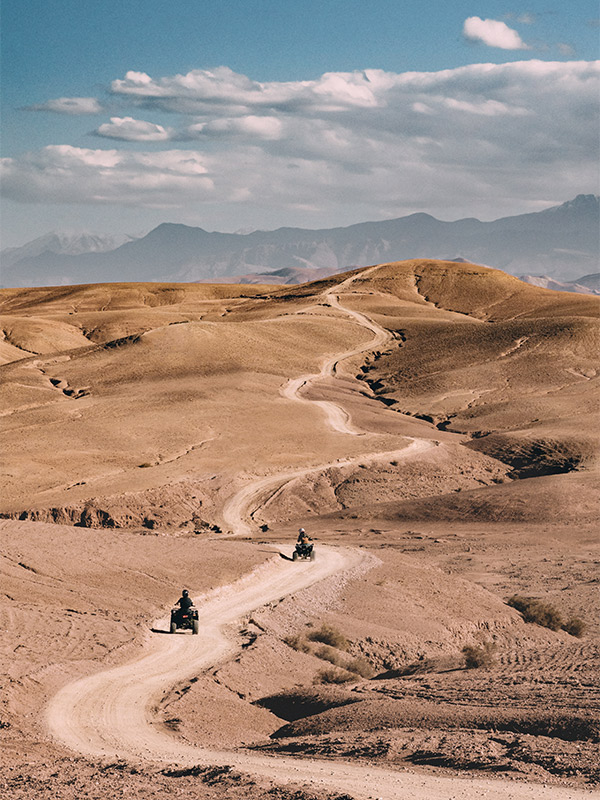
{"left": 330, "top": 261, "right": 600, "bottom": 475}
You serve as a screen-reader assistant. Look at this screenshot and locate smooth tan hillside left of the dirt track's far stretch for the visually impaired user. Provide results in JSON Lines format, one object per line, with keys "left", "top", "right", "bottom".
{"left": 0, "top": 287, "right": 378, "bottom": 511}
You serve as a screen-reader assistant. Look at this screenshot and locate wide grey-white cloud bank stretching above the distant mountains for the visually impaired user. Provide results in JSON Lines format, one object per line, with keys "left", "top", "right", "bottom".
{"left": 2, "top": 59, "right": 600, "bottom": 222}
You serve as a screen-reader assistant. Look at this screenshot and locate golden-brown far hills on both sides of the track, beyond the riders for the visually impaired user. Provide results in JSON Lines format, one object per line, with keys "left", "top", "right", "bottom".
{"left": 0, "top": 260, "right": 600, "bottom": 519}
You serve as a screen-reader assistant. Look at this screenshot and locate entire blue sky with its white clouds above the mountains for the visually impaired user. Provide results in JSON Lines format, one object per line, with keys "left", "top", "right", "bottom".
{"left": 1, "top": 0, "right": 600, "bottom": 247}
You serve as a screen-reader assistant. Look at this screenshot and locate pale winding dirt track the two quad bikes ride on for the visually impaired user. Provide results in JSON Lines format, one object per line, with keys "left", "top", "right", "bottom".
{"left": 46, "top": 281, "right": 590, "bottom": 800}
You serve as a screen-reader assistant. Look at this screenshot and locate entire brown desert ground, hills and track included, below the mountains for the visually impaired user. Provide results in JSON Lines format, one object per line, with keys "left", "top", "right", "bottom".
{"left": 0, "top": 260, "right": 600, "bottom": 800}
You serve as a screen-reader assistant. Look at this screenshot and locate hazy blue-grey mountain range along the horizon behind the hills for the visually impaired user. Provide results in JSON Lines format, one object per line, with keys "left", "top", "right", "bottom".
{"left": 1, "top": 195, "right": 600, "bottom": 286}
